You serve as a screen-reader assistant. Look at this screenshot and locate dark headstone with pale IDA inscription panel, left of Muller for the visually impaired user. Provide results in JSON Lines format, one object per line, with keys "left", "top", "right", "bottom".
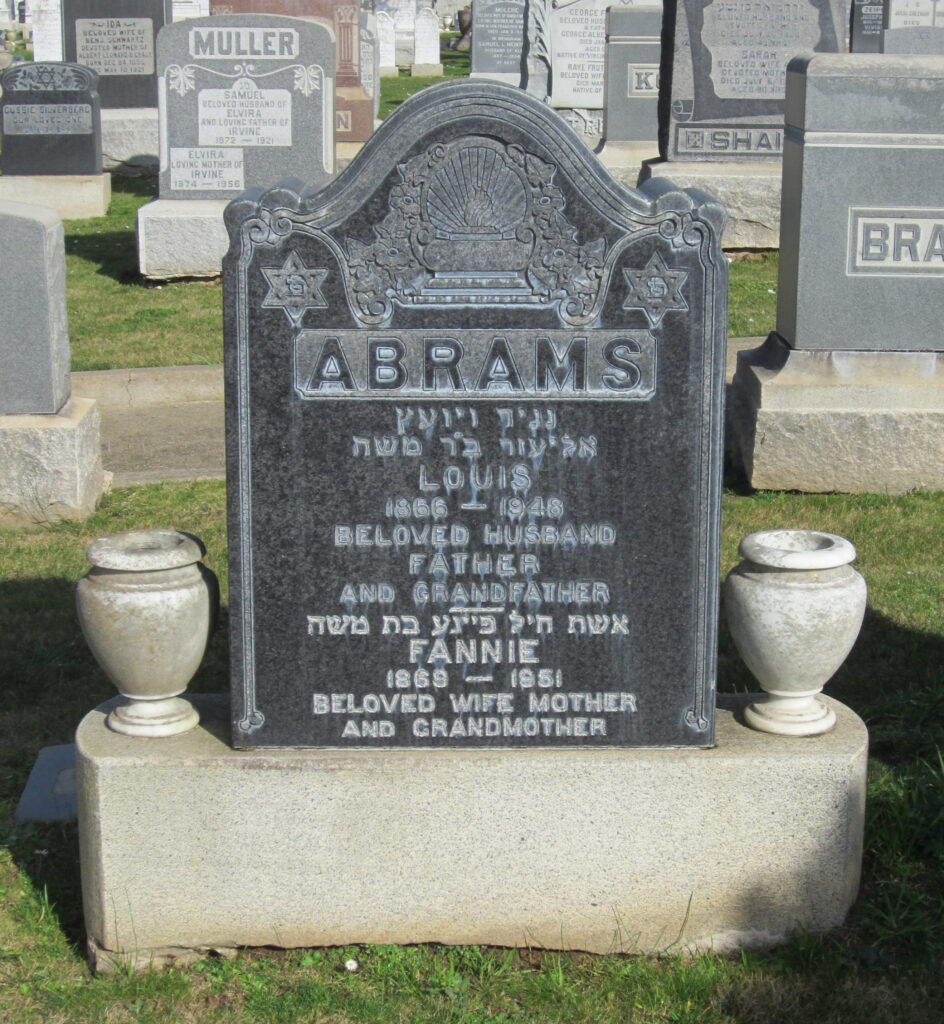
{"left": 62, "top": 0, "right": 173, "bottom": 109}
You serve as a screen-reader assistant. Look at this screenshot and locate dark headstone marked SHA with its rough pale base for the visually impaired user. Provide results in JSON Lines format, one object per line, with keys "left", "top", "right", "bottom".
{"left": 643, "top": 0, "right": 848, "bottom": 248}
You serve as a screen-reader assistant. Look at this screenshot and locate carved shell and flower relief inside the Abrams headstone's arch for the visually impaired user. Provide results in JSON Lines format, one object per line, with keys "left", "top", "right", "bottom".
{"left": 345, "top": 137, "right": 606, "bottom": 321}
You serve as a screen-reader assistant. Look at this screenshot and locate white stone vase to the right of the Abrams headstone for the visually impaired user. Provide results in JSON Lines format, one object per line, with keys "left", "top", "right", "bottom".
{"left": 724, "top": 529, "right": 866, "bottom": 736}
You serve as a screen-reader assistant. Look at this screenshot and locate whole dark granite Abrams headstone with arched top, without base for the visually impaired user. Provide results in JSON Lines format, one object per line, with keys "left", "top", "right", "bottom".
{"left": 223, "top": 81, "right": 727, "bottom": 748}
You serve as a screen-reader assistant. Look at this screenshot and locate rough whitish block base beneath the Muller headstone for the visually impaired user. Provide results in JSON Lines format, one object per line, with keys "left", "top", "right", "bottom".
{"left": 137, "top": 199, "right": 229, "bottom": 281}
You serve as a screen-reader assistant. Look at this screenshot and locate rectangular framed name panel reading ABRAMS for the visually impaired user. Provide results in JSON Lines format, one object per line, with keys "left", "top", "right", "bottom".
{"left": 294, "top": 330, "right": 656, "bottom": 401}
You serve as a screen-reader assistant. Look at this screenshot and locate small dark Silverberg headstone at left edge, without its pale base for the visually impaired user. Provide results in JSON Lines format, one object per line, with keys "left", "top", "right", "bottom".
{"left": 0, "top": 63, "right": 101, "bottom": 174}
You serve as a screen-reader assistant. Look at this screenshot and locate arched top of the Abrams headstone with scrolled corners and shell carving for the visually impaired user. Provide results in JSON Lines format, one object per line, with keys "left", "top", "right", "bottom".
{"left": 227, "top": 82, "right": 724, "bottom": 326}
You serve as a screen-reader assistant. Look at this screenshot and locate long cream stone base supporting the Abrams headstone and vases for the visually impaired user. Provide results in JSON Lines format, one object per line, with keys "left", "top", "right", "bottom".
{"left": 76, "top": 695, "right": 868, "bottom": 969}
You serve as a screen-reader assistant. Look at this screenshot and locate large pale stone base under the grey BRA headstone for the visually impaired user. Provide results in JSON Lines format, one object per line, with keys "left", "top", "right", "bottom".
{"left": 727, "top": 334, "right": 944, "bottom": 494}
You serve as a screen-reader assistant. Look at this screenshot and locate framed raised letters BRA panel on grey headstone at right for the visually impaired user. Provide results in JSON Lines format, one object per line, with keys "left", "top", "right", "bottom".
{"left": 847, "top": 207, "right": 944, "bottom": 278}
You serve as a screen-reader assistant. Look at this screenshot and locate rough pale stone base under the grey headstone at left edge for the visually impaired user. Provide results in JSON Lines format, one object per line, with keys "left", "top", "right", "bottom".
{"left": 0, "top": 397, "right": 111, "bottom": 526}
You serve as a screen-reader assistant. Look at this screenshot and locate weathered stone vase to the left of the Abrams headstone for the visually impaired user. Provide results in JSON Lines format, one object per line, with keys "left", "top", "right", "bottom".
{"left": 76, "top": 529, "right": 219, "bottom": 736}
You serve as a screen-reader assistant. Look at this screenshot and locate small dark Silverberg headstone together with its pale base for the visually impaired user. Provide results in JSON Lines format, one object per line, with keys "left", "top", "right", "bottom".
{"left": 0, "top": 62, "right": 112, "bottom": 218}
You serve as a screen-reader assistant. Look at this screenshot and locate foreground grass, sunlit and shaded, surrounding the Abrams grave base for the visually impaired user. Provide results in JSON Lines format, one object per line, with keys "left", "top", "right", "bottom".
{"left": 0, "top": 482, "right": 944, "bottom": 1024}
